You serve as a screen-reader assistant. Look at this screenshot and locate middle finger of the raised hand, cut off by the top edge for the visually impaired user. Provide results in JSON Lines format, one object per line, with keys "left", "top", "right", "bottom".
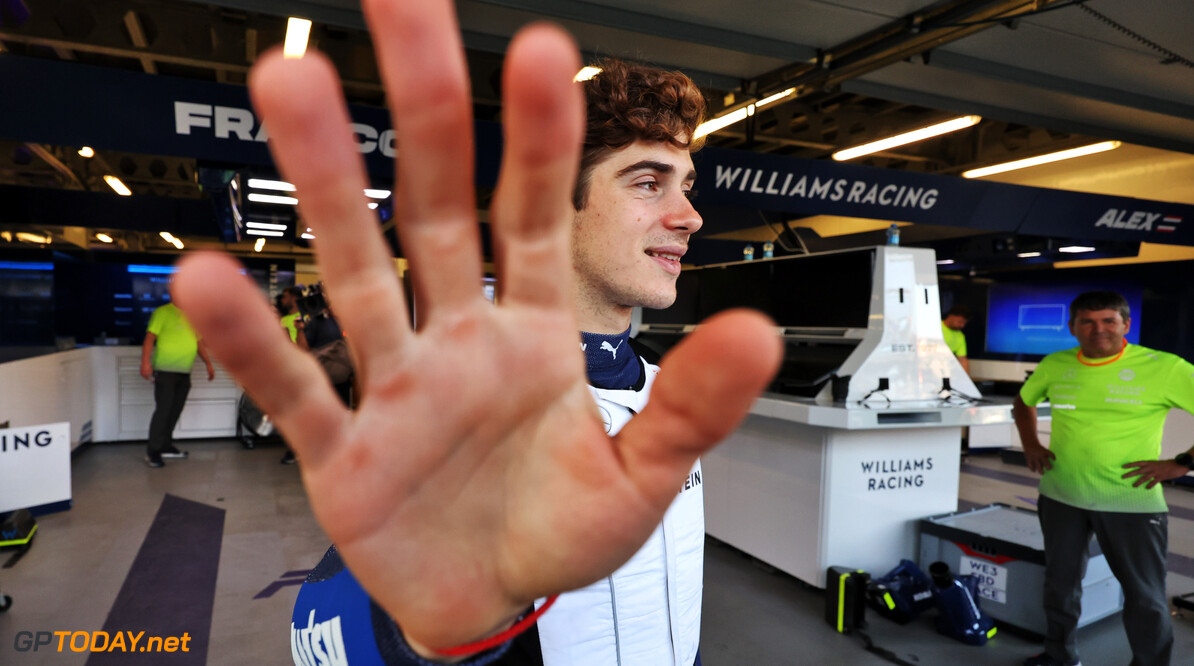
{"left": 362, "top": 0, "right": 481, "bottom": 327}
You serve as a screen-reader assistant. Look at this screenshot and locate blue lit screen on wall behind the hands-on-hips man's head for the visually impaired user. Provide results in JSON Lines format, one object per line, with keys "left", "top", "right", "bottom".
{"left": 986, "top": 283, "right": 1144, "bottom": 356}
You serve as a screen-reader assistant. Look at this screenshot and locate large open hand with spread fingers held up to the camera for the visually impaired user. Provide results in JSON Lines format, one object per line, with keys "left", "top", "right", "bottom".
{"left": 174, "top": 0, "right": 780, "bottom": 648}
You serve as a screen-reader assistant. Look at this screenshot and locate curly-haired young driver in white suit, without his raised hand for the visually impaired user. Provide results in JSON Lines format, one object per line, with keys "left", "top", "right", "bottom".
{"left": 282, "top": 54, "right": 704, "bottom": 666}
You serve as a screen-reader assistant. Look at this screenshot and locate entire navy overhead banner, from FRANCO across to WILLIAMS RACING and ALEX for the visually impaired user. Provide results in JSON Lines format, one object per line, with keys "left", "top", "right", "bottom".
{"left": 0, "top": 54, "right": 1194, "bottom": 245}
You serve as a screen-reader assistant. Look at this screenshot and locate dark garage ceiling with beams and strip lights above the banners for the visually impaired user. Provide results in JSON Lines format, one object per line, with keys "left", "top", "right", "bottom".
{"left": 0, "top": 0, "right": 1194, "bottom": 261}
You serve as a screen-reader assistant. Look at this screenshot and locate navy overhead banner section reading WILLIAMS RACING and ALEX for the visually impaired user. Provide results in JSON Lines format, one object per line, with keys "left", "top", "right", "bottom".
{"left": 694, "top": 148, "right": 1194, "bottom": 245}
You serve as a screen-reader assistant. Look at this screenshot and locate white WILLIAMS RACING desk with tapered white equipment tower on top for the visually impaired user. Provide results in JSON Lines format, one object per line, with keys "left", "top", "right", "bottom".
{"left": 639, "top": 246, "right": 1011, "bottom": 587}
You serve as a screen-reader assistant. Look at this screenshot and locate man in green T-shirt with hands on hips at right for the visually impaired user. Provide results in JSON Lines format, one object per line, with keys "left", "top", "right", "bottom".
{"left": 1013, "top": 291, "right": 1194, "bottom": 666}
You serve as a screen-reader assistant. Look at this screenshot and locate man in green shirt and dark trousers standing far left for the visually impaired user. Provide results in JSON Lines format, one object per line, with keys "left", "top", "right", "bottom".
{"left": 141, "top": 303, "right": 216, "bottom": 467}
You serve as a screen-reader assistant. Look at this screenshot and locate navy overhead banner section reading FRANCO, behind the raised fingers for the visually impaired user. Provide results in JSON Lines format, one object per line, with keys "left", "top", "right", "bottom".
{"left": 0, "top": 54, "right": 501, "bottom": 185}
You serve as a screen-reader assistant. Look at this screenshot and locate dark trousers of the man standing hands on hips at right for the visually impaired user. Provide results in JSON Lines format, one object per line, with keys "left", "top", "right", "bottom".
{"left": 1038, "top": 495, "right": 1174, "bottom": 666}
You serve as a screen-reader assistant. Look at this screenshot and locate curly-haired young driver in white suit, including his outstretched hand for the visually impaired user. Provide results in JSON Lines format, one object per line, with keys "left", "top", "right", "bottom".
{"left": 176, "top": 0, "right": 781, "bottom": 666}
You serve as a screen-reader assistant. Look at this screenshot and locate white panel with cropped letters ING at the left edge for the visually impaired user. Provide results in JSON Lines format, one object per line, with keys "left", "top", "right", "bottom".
{"left": 0, "top": 423, "right": 70, "bottom": 512}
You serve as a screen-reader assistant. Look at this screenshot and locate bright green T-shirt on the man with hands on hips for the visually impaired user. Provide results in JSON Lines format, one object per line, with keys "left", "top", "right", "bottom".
{"left": 1020, "top": 345, "right": 1194, "bottom": 513}
